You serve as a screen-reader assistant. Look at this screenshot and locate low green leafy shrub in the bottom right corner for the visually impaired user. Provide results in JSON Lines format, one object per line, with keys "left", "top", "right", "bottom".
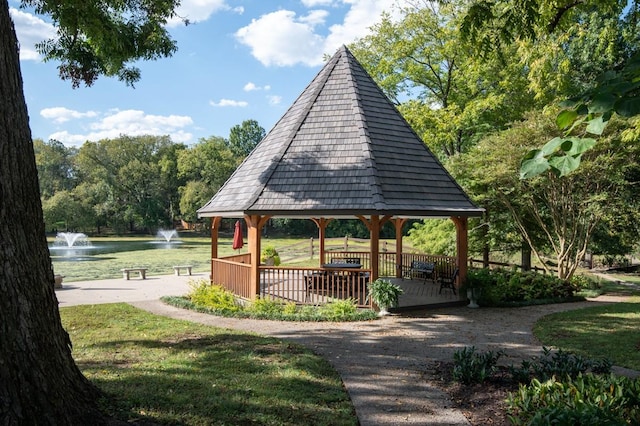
{"left": 507, "top": 374, "right": 640, "bottom": 425}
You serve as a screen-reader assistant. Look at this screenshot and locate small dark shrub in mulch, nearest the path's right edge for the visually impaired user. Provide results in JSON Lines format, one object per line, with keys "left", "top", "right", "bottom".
{"left": 453, "top": 346, "right": 504, "bottom": 384}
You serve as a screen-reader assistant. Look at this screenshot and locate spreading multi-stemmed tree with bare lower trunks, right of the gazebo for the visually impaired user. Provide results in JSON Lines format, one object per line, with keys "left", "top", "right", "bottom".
{"left": 455, "top": 110, "right": 640, "bottom": 278}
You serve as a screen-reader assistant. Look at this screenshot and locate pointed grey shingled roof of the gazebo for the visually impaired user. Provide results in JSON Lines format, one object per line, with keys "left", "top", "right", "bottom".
{"left": 198, "top": 46, "right": 483, "bottom": 218}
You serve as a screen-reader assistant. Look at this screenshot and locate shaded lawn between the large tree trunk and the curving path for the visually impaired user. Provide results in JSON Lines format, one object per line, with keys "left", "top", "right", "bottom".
{"left": 60, "top": 304, "right": 357, "bottom": 425}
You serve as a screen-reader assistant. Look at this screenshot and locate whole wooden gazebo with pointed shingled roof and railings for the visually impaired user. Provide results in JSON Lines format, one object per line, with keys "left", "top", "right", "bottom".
{"left": 198, "top": 46, "right": 483, "bottom": 306}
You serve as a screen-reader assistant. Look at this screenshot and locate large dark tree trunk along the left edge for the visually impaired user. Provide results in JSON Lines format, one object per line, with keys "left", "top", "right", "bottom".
{"left": 0, "top": 0, "right": 101, "bottom": 425}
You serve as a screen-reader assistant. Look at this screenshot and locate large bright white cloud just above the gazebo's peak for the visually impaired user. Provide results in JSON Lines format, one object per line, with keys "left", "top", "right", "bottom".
{"left": 235, "top": 0, "right": 398, "bottom": 66}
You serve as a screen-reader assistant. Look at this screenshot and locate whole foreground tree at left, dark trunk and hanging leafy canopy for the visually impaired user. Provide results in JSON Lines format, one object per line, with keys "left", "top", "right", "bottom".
{"left": 0, "top": 0, "right": 177, "bottom": 425}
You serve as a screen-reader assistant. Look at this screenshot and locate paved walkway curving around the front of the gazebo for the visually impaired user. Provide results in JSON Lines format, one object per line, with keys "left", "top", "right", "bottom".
{"left": 56, "top": 274, "right": 634, "bottom": 426}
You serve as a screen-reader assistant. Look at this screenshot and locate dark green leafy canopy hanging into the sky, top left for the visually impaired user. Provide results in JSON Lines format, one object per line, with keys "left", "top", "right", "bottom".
{"left": 21, "top": 0, "right": 180, "bottom": 87}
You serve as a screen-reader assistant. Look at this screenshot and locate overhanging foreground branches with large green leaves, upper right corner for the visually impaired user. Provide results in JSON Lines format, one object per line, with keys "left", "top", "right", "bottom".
{"left": 461, "top": 0, "right": 640, "bottom": 178}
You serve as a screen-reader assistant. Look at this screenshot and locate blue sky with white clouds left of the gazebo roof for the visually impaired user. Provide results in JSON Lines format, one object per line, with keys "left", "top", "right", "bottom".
{"left": 9, "top": 0, "right": 402, "bottom": 147}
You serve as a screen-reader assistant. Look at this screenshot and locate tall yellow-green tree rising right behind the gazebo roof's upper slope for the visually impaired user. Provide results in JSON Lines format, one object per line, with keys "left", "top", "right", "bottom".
{"left": 351, "top": 2, "right": 534, "bottom": 157}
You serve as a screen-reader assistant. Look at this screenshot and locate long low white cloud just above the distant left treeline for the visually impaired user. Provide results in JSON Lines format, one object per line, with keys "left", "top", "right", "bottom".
{"left": 49, "top": 110, "right": 193, "bottom": 146}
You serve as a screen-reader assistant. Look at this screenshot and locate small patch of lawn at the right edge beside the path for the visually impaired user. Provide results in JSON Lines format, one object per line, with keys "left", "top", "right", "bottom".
{"left": 533, "top": 296, "right": 640, "bottom": 370}
